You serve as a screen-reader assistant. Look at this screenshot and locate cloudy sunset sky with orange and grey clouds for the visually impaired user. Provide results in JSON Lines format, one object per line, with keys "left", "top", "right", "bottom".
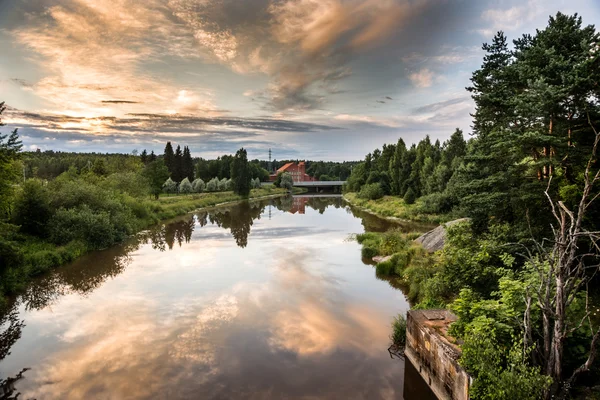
{"left": 0, "top": 0, "right": 600, "bottom": 161}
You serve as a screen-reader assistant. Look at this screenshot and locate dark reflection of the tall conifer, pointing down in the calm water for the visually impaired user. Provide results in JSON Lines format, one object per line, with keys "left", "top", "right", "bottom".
{"left": 208, "top": 201, "right": 265, "bottom": 247}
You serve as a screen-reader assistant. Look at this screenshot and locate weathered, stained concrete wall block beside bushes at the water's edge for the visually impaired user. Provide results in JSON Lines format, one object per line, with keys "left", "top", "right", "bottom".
{"left": 405, "top": 310, "right": 471, "bottom": 400}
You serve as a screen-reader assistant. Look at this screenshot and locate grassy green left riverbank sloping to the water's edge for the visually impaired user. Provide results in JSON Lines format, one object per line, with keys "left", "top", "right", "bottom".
{"left": 0, "top": 186, "right": 303, "bottom": 306}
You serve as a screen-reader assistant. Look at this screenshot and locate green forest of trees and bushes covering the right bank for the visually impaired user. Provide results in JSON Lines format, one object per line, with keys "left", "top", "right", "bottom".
{"left": 346, "top": 13, "right": 600, "bottom": 399}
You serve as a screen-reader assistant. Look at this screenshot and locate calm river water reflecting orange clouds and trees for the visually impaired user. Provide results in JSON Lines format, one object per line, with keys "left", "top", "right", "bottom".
{"left": 0, "top": 196, "right": 432, "bottom": 400}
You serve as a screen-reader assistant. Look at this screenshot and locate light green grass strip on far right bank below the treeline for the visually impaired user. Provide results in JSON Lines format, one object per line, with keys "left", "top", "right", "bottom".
{"left": 344, "top": 193, "right": 452, "bottom": 223}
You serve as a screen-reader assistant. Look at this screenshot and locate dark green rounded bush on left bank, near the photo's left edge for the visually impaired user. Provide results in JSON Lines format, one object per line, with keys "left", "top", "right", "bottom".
{"left": 14, "top": 179, "right": 52, "bottom": 237}
